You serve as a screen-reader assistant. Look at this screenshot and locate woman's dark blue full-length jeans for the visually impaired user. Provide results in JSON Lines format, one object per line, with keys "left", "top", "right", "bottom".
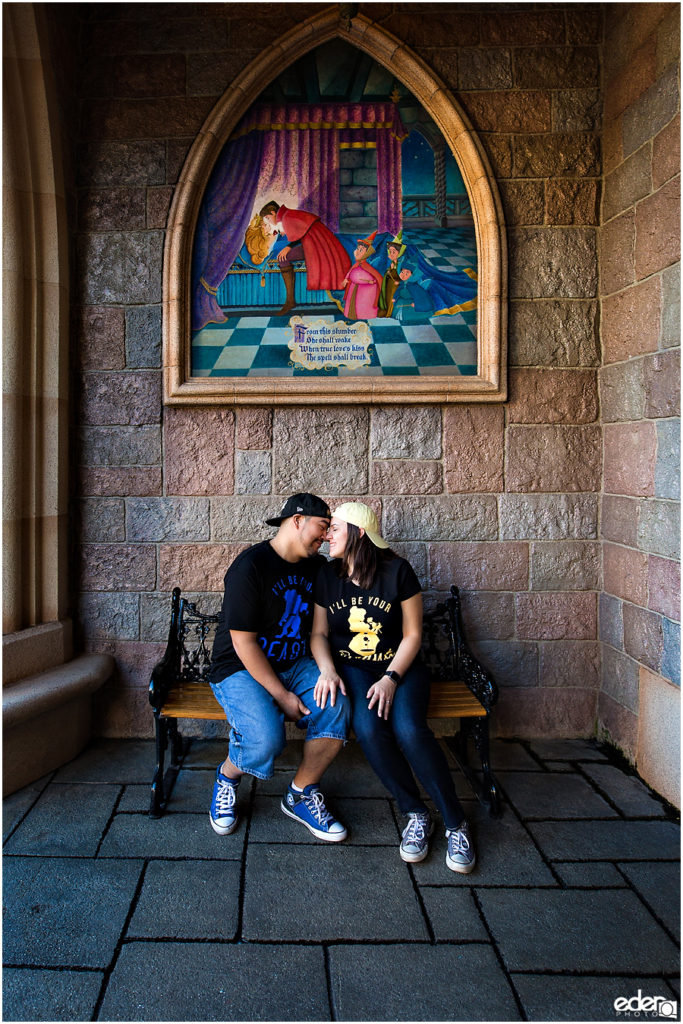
{"left": 337, "top": 664, "right": 465, "bottom": 828}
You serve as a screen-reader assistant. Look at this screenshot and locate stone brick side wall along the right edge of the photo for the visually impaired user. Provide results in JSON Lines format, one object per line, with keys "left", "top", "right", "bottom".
{"left": 599, "top": 3, "right": 680, "bottom": 770}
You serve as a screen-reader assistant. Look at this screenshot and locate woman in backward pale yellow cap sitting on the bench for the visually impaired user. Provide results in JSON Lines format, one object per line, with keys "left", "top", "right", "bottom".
{"left": 310, "top": 502, "right": 475, "bottom": 874}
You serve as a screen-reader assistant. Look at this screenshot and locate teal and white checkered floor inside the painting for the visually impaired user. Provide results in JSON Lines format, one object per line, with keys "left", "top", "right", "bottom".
{"left": 191, "top": 228, "right": 477, "bottom": 378}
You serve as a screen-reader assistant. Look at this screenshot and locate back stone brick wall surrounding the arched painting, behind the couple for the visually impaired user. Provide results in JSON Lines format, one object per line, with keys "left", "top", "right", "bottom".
{"left": 66, "top": 3, "right": 655, "bottom": 735}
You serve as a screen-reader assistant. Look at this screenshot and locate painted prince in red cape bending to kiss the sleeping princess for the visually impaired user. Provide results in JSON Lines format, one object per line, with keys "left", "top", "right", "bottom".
{"left": 260, "top": 200, "right": 351, "bottom": 316}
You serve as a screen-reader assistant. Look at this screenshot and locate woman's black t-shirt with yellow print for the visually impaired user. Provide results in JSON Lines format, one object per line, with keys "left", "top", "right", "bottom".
{"left": 315, "top": 555, "right": 421, "bottom": 668}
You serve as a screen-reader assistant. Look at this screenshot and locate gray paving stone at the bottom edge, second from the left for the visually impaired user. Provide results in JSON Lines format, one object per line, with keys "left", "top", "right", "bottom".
{"left": 99, "top": 942, "right": 330, "bottom": 1021}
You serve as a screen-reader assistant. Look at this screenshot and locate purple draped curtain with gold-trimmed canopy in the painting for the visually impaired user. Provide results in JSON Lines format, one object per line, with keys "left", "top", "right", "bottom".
{"left": 193, "top": 102, "right": 408, "bottom": 331}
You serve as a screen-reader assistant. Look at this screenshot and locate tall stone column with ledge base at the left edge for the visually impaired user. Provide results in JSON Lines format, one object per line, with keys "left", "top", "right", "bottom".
{"left": 3, "top": 3, "right": 113, "bottom": 793}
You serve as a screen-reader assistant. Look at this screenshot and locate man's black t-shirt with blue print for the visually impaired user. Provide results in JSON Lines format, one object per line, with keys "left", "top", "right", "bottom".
{"left": 210, "top": 541, "right": 326, "bottom": 683}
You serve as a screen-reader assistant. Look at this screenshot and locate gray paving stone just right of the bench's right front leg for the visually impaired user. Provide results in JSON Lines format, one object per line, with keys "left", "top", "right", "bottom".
{"left": 498, "top": 772, "right": 618, "bottom": 819}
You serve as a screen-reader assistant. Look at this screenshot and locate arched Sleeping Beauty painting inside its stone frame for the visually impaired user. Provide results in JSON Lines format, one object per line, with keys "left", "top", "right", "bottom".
{"left": 190, "top": 40, "right": 477, "bottom": 377}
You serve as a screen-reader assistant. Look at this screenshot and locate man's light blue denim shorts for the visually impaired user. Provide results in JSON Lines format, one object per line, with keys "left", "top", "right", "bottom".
{"left": 211, "top": 657, "right": 351, "bottom": 778}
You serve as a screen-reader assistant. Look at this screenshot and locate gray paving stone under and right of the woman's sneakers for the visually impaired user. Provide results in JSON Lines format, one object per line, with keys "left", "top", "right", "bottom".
{"left": 414, "top": 804, "right": 557, "bottom": 886}
